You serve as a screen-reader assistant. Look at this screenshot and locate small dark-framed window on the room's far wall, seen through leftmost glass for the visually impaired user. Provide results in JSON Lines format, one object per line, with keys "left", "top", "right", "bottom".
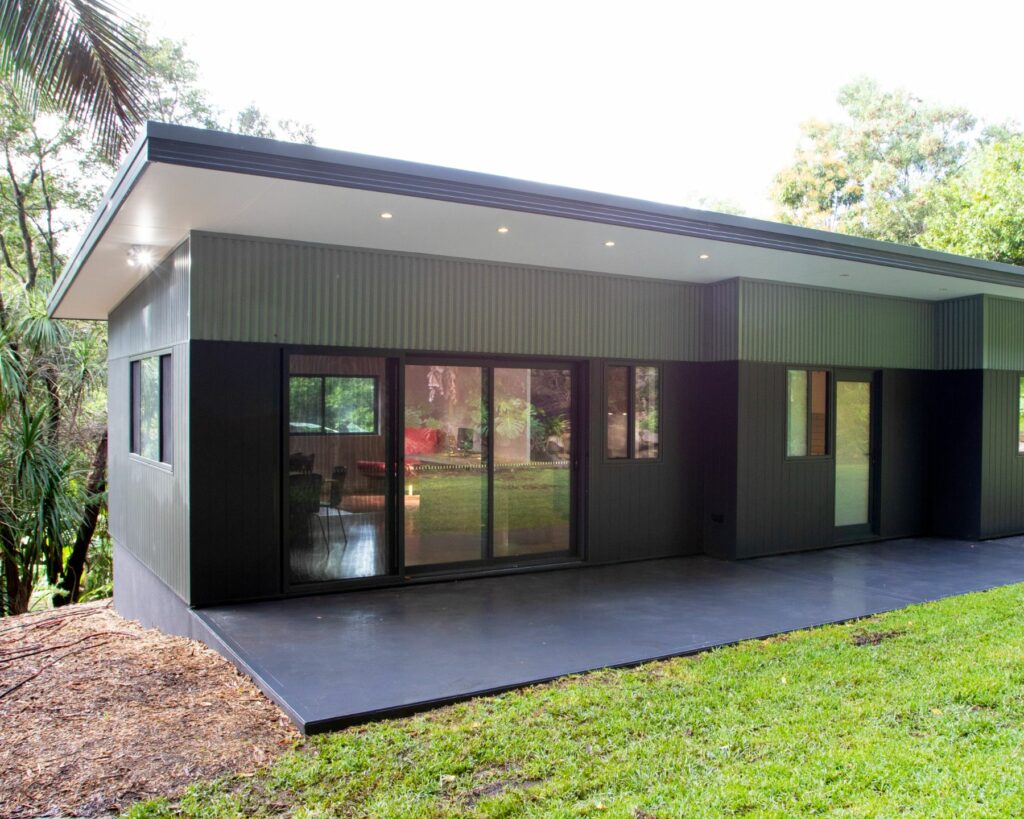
{"left": 288, "top": 376, "right": 379, "bottom": 435}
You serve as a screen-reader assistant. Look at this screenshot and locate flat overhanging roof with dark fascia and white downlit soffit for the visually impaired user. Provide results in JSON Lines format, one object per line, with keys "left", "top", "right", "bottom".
{"left": 49, "top": 122, "right": 1024, "bottom": 319}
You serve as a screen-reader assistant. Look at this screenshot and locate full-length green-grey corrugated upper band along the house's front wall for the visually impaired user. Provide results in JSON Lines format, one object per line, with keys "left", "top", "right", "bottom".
{"left": 190, "top": 231, "right": 1024, "bottom": 370}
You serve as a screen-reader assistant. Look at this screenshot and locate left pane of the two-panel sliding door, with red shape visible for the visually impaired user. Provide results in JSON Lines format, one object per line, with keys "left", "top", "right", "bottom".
{"left": 402, "top": 364, "right": 488, "bottom": 566}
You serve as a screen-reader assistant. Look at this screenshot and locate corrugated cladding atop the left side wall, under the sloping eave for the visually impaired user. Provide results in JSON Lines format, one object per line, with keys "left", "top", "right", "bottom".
{"left": 108, "top": 242, "right": 189, "bottom": 358}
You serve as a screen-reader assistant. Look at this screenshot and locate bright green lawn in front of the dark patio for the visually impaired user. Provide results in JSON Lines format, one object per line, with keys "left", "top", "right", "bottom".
{"left": 129, "top": 586, "right": 1024, "bottom": 819}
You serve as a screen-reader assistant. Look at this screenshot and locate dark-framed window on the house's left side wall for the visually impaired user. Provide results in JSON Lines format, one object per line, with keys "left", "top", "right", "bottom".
{"left": 129, "top": 355, "right": 174, "bottom": 464}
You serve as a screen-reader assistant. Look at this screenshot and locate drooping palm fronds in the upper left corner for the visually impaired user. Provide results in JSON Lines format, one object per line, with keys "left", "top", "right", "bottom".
{"left": 0, "top": 0, "right": 146, "bottom": 159}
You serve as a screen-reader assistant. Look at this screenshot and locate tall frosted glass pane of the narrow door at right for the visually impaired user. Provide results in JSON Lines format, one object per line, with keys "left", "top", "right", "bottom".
{"left": 836, "top": 381, "right": 871, "bottom": 527}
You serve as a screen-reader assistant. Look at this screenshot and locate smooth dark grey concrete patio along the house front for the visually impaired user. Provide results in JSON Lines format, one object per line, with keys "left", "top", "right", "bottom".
{"left": 196, "top": 537, "right": 1024, "bottom": 732}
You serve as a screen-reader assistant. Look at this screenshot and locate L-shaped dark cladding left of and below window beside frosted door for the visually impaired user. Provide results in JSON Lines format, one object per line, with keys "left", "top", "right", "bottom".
{"left": 735, "top": 362, "right": 835, "bottom": 558}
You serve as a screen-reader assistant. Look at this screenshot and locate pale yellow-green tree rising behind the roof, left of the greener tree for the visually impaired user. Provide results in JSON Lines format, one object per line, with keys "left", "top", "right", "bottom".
{"left": 774, "top": 79, "right": 985, "bottom": 244}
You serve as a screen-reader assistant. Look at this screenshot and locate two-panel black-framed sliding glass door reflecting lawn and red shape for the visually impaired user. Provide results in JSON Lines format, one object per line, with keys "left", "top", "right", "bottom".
{"left": 402, "top": 361, "right": 574, "bottom": 571}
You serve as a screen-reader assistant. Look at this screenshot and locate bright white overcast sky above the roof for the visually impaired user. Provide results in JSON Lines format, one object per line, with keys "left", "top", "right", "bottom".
{"left": 123, "top": 0, "right": 1024, "bottom": 218}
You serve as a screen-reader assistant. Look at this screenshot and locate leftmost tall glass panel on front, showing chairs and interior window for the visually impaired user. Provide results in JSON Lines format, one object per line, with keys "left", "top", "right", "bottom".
{"left": 285, "top": 354, "right": 391, "bottom": 585}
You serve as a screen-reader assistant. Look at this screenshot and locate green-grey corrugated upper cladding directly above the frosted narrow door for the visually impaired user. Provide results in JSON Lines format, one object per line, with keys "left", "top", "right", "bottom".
{"left": 739, "top": 279, "right": 934, "bottom": 369}
